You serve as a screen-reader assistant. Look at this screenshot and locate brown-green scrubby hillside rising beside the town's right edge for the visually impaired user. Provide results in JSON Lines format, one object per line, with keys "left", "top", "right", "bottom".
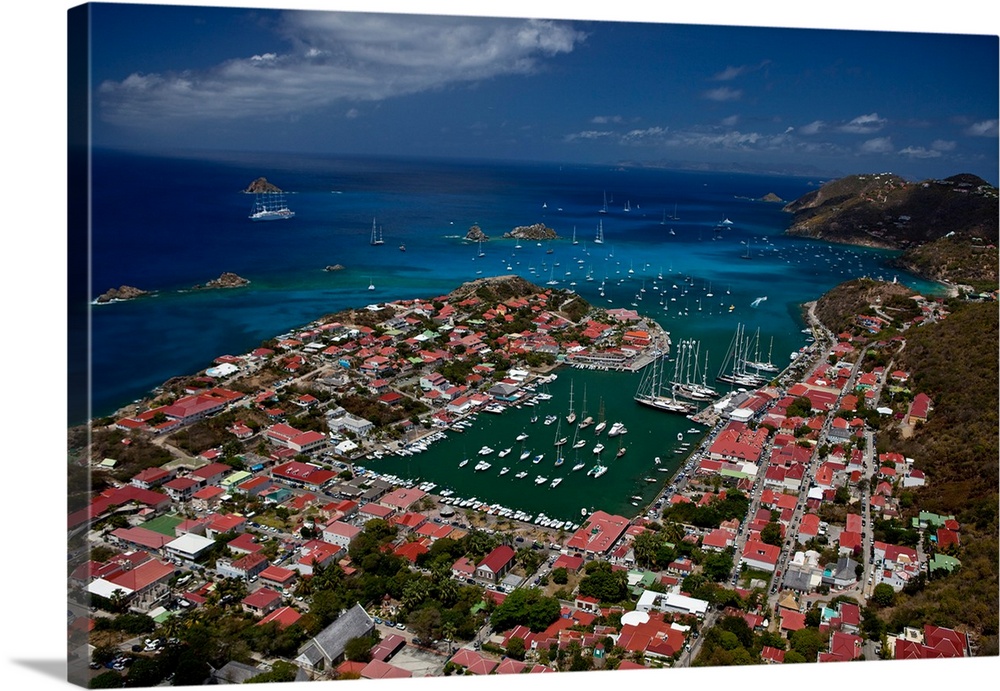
{"left": 817, "top": 279, "right": 1000, "bottom": 655}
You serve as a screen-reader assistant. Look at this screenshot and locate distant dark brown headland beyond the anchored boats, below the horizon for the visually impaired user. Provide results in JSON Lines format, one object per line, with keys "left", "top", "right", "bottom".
{"left": 784, "top": 173, "right": 998, "bottom": 284}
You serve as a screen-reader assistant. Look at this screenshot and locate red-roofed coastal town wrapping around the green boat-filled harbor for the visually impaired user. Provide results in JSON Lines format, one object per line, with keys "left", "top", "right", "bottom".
{"left": 68, "top": 277, "right": 977, "bottom": 686}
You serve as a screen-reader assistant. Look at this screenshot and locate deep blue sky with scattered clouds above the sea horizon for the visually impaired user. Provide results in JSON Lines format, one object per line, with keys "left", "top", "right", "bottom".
{"left": 86, "top": 2, "right": 1000, "bottom": 184}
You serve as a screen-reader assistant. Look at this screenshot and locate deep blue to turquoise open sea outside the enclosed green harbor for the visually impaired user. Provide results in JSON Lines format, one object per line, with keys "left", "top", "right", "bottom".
{"left": 82, "top": 150, "right": 935, "bottom": 422}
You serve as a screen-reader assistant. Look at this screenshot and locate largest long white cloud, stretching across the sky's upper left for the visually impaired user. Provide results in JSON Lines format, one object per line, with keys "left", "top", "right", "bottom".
{"left": 98, "top": 12, "right": 586, "bottom": 127}
